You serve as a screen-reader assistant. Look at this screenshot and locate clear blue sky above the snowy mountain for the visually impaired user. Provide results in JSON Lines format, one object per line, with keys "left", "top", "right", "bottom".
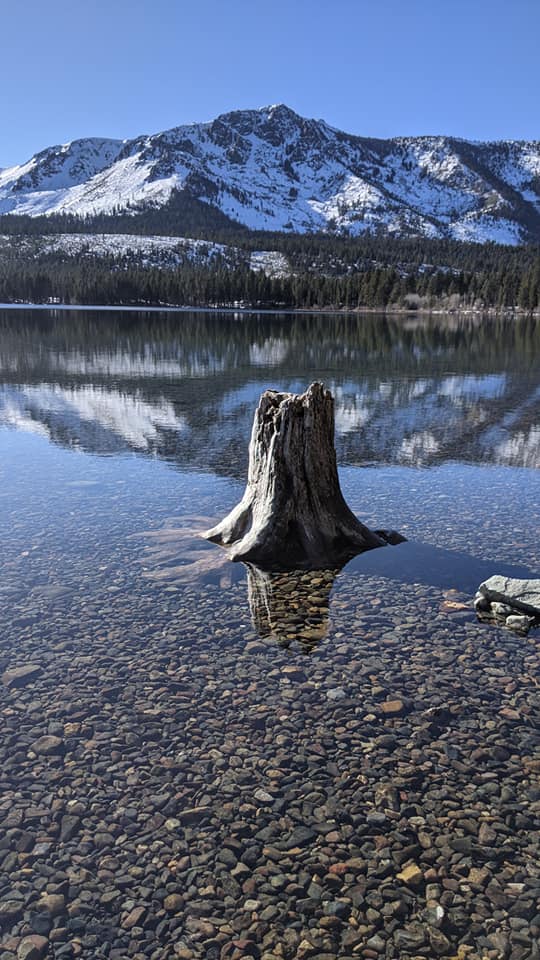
{"left": 0, "top": 0, "right": 540, "bottom": 167}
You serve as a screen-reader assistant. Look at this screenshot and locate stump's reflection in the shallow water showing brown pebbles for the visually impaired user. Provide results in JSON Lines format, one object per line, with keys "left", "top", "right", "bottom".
{"left": 246, "top": 564, "right": 339, "bottom": 653}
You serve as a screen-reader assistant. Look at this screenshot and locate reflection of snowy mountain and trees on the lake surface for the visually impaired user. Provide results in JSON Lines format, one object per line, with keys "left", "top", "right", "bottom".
{"left": 0, "top": 309, "right": 540, "bottom": 478}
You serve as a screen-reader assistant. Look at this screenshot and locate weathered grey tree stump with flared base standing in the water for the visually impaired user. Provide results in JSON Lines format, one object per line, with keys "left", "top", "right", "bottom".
{"left": 203, "top": 383, "right": 403, "bottom": 570}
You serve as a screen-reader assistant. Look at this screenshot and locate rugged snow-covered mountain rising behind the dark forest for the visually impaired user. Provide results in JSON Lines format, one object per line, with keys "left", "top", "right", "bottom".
{"left": 0, "top": 105, "right": 540, "bottom": 244}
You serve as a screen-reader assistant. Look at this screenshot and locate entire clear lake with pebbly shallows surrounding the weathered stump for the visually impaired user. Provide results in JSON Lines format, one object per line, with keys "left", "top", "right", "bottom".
{"left": 0, "top": 308, "right": 540, "bottom": 960}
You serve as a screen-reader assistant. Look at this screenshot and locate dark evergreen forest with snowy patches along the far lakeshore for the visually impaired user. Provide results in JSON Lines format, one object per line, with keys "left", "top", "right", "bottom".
{"left": 0, "top": 216, "right": 540, "bottom": 312}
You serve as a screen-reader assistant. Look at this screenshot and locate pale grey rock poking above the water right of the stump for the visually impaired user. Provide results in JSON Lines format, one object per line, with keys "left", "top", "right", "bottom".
{"left": 474, "top": 575, "right": 540, "bottom": 633}
